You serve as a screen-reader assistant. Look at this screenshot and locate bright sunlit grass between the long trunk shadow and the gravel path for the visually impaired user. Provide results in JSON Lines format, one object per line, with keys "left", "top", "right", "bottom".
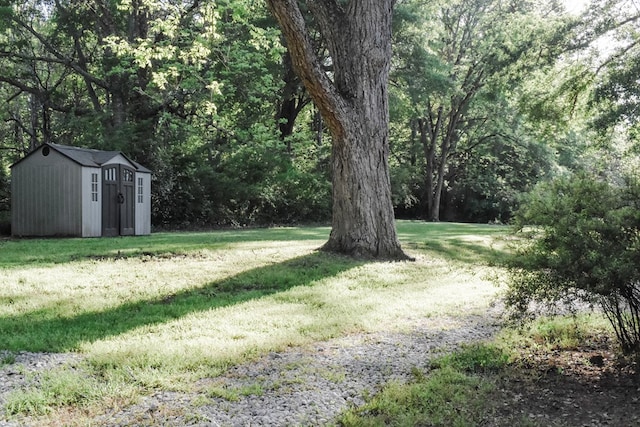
{"left": 75, "top": 255, "right": 497, "bottom": 387}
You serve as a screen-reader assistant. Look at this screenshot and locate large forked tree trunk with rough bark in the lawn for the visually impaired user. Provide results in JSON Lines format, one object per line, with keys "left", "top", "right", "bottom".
{"left": 267, "top": 0, "right": 407, "bottom": 259}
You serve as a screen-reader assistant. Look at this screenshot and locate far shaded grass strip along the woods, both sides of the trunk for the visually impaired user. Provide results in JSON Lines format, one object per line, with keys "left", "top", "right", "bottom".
{"left": 0, "top": 221, "right": 508, "bottom": 269}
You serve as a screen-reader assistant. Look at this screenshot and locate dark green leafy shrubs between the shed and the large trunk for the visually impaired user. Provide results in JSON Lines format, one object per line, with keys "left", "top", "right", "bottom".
{"left": 152, "top": 131, "right": 331, "bottom": 229}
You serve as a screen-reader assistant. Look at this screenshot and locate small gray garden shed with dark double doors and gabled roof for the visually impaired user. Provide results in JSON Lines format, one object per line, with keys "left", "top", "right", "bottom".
{"left": 11, "top": 143, "right": 151, "bottom": 237}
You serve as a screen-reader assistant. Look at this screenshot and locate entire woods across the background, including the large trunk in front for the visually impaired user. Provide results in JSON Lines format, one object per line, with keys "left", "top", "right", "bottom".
{"left": 0, "top": 0, "right": 638, "bottom": 234}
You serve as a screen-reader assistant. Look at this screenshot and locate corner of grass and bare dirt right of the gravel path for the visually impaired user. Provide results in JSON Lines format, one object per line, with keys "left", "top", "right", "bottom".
{"left": 339, "top": 314, "right": 640, "bottom": 427}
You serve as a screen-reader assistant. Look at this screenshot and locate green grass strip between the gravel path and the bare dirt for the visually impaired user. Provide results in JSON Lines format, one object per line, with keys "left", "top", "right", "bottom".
{"left": 339, "top": 313, "right": 613, "bottom": 427}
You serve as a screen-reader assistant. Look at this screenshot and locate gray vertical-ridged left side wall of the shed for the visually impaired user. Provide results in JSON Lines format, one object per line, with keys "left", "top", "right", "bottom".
{"left": 11, "top": 150, "right": 82, "bottom": 236}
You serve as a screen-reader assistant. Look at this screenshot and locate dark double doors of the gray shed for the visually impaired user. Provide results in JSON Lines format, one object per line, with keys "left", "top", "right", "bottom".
{"left": 102, "top": 165, "right": 135, "bottom": 236}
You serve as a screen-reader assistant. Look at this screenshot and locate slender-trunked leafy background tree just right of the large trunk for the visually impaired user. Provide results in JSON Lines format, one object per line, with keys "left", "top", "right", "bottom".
{"left": 393, "top": 0, "right": 566, "bottom": 221}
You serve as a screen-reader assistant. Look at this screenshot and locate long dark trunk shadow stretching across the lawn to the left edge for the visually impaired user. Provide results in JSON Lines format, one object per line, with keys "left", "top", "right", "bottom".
{"left": 0, "top": 251, "right": 363, "bottom": 352}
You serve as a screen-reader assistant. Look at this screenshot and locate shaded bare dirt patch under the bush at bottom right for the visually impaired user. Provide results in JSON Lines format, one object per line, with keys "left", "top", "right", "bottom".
{"left": 495, "top": 336, "right": 640, "bottom": 427}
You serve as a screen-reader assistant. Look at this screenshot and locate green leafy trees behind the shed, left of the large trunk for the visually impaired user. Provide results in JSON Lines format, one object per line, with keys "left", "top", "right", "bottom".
{"left": 0, "top": 0, "right": 330, "bottom": 231}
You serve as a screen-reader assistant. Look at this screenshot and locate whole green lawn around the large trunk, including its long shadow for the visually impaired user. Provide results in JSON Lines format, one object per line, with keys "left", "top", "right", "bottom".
{"left": 0, "top": 221, "right": 507, "bottom": 422}
